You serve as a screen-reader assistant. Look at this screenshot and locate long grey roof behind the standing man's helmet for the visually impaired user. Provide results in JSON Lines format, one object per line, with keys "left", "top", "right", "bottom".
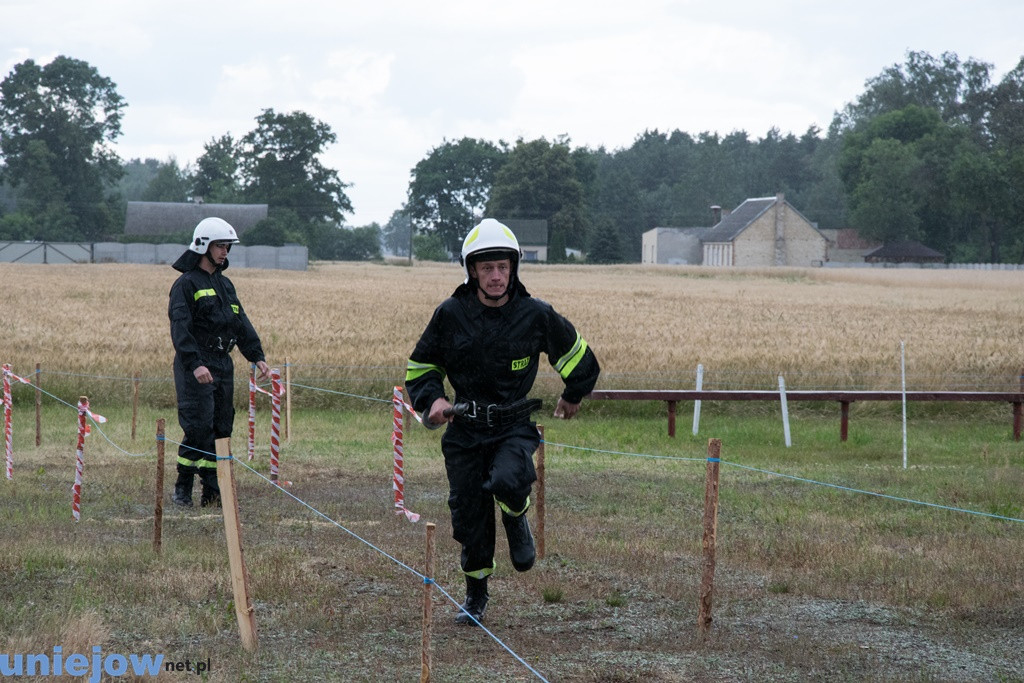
{"left": 125, "top": 202, "right": 267, "bottom": 234}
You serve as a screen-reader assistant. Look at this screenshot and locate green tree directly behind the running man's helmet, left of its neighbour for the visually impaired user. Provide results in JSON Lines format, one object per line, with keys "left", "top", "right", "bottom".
{"left": 406, "top": 137, "right": 507, "bottom": 254}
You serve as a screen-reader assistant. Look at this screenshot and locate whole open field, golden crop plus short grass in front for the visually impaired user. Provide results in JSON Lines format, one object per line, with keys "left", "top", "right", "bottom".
{"left": 0, "top": 259, "right": 1024, "bottom": 682}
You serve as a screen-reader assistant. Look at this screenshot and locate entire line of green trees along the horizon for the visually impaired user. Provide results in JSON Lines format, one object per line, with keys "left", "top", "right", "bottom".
{"left": 0, "top": 51, "right": 1024, "bottom": 263}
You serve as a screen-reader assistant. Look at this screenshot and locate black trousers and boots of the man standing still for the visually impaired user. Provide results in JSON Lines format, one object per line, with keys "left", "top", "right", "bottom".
{"left": 174, "top": 352, "right": 234, "bottom": 503}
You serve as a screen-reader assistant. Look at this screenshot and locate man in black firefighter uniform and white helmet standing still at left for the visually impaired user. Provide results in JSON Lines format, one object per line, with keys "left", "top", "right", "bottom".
{"left": 167, "top": 218, "right": 269, "bottom": 508}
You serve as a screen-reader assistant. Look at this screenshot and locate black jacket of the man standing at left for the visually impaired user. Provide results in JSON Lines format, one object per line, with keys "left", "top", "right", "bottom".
{"left": 167, "top": 251, "right": 265, "bottom": 372}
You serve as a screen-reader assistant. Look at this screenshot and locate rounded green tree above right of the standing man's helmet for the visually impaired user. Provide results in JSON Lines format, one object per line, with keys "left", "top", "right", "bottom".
{"left": 239, "top": 109, "right": 352, "bottom": 224}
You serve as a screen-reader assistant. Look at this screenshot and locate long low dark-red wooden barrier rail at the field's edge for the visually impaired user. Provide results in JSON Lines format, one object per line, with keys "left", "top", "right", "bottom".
{"left": 587, "top": 389, "right": 1024, "bottom": 441}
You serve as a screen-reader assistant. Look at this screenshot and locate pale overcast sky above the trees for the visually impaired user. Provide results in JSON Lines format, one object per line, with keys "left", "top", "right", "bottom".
{"left": 6, "top": 0, "right": 1024, "bottom": 225}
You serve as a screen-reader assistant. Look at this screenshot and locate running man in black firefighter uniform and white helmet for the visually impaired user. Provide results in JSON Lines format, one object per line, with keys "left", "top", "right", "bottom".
{"left": 406, "top": 218, "right": 600, "bottom": 624}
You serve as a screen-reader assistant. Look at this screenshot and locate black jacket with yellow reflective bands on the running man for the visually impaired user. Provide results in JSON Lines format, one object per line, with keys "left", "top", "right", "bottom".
{"left": 406, "top": 281, "right": 601, "bottom": 415}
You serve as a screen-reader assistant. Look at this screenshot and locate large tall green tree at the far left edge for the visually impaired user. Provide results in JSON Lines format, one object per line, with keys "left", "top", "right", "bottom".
{"left": 0, "top": 55, "right": 125, "bottom": 240}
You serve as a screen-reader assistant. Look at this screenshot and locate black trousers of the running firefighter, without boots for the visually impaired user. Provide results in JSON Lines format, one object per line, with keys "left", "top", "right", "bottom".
{"left": 441, "top": 422, "right": 541, "bottom": 579}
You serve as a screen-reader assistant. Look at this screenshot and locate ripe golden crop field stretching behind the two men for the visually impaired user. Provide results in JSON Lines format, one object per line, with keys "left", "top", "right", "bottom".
{"left": 0, "top": 263, "right": 1024, "bottom": 390}
